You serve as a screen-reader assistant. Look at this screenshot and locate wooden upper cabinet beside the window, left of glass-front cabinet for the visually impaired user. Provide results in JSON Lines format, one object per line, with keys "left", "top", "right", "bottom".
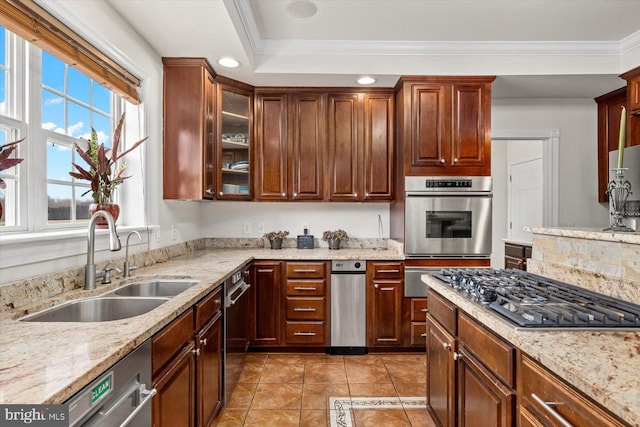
{"left": 162, "top": 58, "right": 216, "bottom": 200}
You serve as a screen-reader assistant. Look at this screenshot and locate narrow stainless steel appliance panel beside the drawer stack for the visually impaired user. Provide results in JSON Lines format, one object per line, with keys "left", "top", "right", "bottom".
{"left": 327, "top": 260, "right": 367, "bottom": 354}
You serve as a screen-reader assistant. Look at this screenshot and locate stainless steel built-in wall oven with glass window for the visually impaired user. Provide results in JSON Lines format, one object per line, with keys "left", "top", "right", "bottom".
{"left": 404, "top": 176, "right": 492, "bottom": 259}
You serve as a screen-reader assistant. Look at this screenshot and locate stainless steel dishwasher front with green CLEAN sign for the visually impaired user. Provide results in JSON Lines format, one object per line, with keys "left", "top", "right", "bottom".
{"left": 66, "top": 341, "right": 156, "bottom": 427}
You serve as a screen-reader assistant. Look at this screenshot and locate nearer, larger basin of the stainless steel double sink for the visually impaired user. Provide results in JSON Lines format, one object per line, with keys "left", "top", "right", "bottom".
{"left": 20, "top": 297, "right": 169, "bottom": 322}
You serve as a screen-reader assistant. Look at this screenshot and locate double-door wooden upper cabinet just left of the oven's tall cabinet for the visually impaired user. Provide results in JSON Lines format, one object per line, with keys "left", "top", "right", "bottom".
{"left": 327, "top": 92, "right": 395, "bottom": 201}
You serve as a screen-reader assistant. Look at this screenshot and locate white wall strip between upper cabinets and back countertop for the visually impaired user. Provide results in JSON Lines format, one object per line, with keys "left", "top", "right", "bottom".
{"left": 201, "top": 202, "right": 389, "bottom": 238}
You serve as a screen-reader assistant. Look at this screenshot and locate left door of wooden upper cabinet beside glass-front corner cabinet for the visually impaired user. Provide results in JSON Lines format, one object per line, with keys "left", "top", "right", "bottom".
{"left": 254, "top": 92, "right": 289, "bottom": 200}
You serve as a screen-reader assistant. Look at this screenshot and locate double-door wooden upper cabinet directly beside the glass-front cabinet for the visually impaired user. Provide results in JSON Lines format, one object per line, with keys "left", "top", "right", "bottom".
{"left": 256, "top": 89, "right": 326, "bottom": 200}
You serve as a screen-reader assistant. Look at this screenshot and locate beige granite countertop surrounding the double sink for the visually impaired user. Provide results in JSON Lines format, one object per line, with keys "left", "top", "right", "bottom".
{"left": 0, "top": 248, "right": 403, "bottom": 404}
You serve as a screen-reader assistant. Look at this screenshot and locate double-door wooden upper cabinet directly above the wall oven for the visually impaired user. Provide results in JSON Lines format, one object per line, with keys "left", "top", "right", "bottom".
{"left": 396, "top": 77, "right": 495, "bottom": 176}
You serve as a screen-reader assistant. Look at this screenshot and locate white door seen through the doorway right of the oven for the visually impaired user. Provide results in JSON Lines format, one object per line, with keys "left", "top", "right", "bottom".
{"left": 509, "top": 158, "right": 542, "bottom": 241}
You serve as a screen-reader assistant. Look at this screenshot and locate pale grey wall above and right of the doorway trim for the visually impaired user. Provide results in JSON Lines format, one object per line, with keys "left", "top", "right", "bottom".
{"left": 491, "top": 99, "right": 609, "bottom": 227}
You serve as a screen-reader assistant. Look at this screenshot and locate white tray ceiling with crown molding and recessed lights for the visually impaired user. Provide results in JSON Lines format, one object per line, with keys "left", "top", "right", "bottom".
{"left": 101, "top": 0, "right": 640, "bottom": 98}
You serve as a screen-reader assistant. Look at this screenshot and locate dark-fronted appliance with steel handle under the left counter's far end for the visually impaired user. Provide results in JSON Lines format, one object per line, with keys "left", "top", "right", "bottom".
{"left": 223, "top": 267, "right": 251, "bottom": 402}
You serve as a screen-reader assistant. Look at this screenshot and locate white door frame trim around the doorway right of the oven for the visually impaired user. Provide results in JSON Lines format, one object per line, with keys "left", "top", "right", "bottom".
{"left": 491, "top": 129, "right": 560, "bottom": 227}
